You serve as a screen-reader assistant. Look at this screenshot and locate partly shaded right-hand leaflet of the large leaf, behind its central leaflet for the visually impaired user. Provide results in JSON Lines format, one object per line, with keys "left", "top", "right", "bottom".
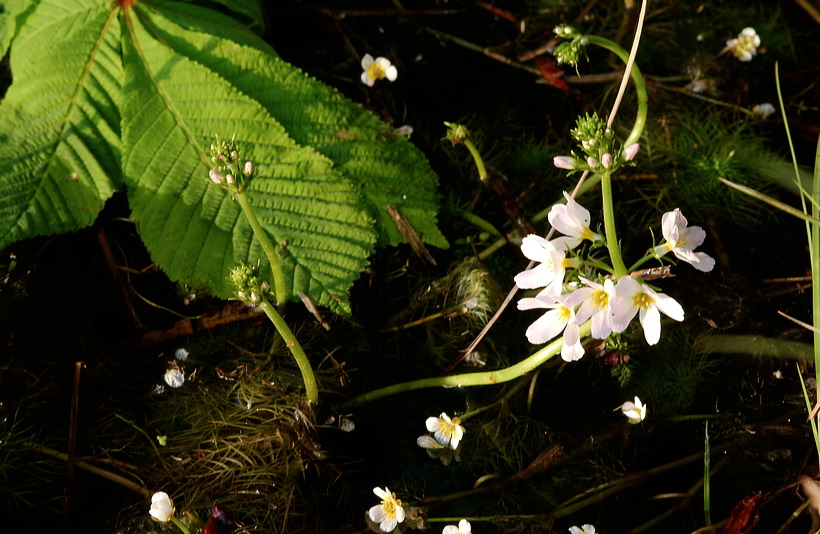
{"left": 138, "top": 0, "right": 448, "bottom": 248}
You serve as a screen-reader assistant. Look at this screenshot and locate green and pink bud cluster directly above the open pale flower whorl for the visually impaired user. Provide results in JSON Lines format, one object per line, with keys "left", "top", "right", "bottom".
{"left": 552, "top": 113, "right": 640, "bottom": 174}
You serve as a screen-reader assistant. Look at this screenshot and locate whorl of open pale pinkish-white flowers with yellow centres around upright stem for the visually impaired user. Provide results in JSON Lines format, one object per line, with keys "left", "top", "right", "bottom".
{"left": 515, "top": 193, "right": 715, "bottom": 354}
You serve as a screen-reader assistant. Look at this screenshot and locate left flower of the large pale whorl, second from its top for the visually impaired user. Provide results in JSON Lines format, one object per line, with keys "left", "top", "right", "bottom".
{"left": 514, "top": 234, "right": 578, "bottom": 296}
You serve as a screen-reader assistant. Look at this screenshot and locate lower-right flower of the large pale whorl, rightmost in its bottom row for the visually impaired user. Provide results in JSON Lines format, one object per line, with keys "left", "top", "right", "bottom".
{"left": 611, "top": 276, "right": 683, "bottom": 345}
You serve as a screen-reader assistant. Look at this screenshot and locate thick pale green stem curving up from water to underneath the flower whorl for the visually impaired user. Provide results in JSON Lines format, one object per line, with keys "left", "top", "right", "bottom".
{"left": 344, "top": 321, "right": 592, "bottom": 408}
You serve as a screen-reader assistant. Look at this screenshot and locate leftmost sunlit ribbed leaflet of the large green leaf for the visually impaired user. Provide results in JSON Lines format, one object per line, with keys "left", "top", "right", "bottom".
{"left": 0, "top": 0, "right": 122, "bottom": 243}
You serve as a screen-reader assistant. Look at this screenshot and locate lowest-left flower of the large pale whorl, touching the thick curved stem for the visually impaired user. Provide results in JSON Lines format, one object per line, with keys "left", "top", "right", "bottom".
{"left": 518, "top": 291, "right": 584, "bottom": 362}
